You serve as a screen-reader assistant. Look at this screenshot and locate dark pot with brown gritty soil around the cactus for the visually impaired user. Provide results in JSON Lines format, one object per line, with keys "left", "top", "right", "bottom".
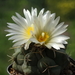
{"left": 7, "top": 57, "right": 75, "bottom": 75}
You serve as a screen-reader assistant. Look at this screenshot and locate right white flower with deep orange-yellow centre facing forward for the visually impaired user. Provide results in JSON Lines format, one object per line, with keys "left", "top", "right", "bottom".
{"left": 31, "top": 9, "right": 69, "bottom": 50}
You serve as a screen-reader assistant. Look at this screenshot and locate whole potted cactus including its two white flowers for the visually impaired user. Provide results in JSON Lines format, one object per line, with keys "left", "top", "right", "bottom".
{"left": 6, "top": 8, "right": 70, "bottom": 75}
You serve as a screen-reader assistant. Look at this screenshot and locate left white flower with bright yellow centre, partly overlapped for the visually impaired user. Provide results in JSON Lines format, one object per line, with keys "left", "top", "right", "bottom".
{"left": 6, "top": 8, "right": 37, "bottom": 49}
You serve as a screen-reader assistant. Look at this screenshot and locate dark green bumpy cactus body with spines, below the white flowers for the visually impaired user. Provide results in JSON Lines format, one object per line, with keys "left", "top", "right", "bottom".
{"left": 12, "top": 43, "right": 70, "bottom": 75}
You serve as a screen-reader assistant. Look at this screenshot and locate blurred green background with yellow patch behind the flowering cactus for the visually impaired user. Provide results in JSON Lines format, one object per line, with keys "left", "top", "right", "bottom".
{"left": 0, "top": 0, "right": 75, "bottom": 75}
